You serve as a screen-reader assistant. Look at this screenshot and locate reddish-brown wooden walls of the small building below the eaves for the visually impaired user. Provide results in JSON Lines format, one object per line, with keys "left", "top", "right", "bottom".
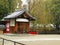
{"left": 10, "top": 22, "right": 30, "bottom": 33}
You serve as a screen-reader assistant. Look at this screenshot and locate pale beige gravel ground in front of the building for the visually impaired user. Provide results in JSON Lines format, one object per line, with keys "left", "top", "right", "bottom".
{"left": 0, "top": 34, "right": 60, "bottom": 45}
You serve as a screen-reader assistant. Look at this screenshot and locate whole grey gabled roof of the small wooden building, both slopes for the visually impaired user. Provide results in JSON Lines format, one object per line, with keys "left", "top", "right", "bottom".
{"left": 4, "top": 10, "right": 35, "bottom": 20}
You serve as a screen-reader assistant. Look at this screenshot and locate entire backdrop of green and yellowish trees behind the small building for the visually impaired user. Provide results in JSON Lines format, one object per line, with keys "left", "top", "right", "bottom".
{"left": 0, "top": 0, "right": 60, "bottom": 33}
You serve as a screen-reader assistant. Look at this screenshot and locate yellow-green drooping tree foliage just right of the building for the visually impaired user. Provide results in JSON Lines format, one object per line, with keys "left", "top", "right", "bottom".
{"left": 30, "top": 0, "right": 54, "bottom": 30}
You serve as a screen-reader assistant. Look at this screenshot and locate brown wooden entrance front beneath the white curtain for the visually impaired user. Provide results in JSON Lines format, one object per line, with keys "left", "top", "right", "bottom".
{"left": 17, "top": 22, "right": 29, "bottom": 33}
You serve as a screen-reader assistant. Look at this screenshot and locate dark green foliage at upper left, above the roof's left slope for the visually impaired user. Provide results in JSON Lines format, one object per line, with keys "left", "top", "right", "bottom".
{"left": 0, "top": 0, "right": 16, "bottom": 20}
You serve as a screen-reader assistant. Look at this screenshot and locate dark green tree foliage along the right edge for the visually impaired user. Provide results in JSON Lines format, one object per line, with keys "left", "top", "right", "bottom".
{"left": 49, "top": 0, "right": 60, "bottom": 29}
